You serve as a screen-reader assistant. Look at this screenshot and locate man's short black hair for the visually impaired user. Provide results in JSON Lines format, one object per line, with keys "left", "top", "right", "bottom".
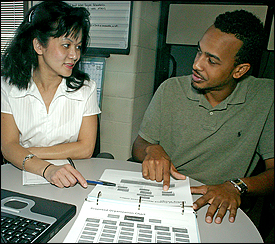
{"left": 214, "top": 9, "right": 267, "bottom": 66}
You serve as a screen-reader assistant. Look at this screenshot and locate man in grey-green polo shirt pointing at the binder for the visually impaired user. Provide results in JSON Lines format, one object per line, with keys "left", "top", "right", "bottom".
{"left": 132, "top": 10, "right": 274, "bottom": 226}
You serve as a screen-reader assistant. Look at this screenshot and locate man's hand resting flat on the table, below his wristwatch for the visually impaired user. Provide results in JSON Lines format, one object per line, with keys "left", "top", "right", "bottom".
{"left": 191, "top": 182, "right": 241, "bottom": 224}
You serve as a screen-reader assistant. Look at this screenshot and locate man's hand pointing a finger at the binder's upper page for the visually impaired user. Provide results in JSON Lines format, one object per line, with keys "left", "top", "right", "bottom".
{"left": 142, "top": 145, "right": 186, "bottom": 191}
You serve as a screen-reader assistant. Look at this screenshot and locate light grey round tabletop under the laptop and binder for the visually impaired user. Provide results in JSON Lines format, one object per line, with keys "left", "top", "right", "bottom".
{"left": 1, "top": 158, "right": 263, "bottom": 243}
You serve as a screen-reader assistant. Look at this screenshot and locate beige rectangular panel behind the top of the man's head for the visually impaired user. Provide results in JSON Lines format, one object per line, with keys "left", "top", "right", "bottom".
{"left": 167, "top": 3, "right": 268, "bottom": 45}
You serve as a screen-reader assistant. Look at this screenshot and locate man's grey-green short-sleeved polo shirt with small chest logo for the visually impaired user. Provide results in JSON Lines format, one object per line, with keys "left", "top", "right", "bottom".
{"left": 139, "top": 76, "right": 274, "bottom": 184}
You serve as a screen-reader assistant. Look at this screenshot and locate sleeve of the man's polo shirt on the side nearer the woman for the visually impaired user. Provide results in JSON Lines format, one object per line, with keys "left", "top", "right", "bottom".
{"left": 138, "top": 84, "right": 164, "bottom": 144}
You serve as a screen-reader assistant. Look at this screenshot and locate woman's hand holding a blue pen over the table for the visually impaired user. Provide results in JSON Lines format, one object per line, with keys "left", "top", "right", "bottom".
{"left": 45, "top": 164, "right": 87, "bottom": 188}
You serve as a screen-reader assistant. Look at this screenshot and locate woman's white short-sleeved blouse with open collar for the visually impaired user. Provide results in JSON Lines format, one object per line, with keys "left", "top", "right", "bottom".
{"left": 1, "top": 77, "right": 101, "bottom": 148}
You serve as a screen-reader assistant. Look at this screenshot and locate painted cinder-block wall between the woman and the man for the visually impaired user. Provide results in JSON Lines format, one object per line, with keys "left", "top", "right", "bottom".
{"left": 100, "top": 1, "right": 160, "bottom": 160}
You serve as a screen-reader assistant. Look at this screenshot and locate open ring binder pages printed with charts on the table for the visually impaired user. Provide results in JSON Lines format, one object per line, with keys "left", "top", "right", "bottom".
{"left": 64, "top": 169, "right": 200, "bottom": 243}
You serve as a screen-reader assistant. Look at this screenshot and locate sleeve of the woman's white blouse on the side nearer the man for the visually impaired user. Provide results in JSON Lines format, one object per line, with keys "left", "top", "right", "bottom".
{"left": 83, "top": 80, "right": 101, "bottom": 116}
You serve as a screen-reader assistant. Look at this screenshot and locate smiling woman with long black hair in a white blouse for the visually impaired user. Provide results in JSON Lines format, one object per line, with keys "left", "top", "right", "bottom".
{"left": 1, "top": 1, "right": 100, "bottom": 187}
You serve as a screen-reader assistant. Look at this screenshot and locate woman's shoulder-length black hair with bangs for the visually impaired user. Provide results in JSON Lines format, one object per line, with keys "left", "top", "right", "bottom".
{"left": 1, "top": 1, "right": 90, "bottom": 90}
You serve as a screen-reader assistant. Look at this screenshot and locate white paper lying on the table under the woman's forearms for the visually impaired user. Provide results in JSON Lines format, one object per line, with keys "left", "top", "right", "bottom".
{"left": 22, "top": 159, "right": 69, "bottom": 185}
